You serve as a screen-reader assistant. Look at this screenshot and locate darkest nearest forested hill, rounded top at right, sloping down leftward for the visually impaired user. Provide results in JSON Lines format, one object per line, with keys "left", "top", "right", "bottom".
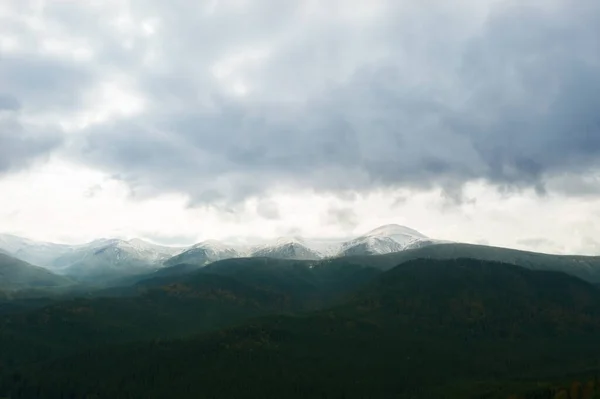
{"left": 0, "top": 259, "right": 600, "bottom": 399}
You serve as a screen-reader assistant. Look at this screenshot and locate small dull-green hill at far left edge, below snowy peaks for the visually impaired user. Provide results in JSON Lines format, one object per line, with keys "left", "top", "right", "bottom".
{"left": 0, "top": 253, "right": 73, "bottom": 290}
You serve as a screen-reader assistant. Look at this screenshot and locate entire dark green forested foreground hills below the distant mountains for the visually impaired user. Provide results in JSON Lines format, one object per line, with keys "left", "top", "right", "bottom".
{"left": 0, "top": 258, "right": 600, "bottom": 399}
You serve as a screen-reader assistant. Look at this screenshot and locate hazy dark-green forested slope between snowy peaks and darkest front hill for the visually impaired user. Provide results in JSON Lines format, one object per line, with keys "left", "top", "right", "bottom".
{"left": 0, "top": 258, "right": 379, "bottom": 364}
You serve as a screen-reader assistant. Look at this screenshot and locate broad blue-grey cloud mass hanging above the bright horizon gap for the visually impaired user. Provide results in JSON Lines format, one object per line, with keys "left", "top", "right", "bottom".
{"left": 1, "top": 0, "right": 600, "bottom": 204}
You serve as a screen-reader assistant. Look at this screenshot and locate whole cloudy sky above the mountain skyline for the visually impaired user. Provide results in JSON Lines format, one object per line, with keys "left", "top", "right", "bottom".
{"left": 0, "top": 0, "right": 600, "bottom": 254}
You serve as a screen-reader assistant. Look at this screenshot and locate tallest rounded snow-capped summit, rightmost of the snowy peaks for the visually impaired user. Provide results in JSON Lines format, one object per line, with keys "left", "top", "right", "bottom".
{"left": 337, "top": 224, "right": 436, "bottom": 256}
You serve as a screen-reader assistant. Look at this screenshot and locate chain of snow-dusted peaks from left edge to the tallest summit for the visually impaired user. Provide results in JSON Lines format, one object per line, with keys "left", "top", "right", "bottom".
{"left": 0, "top": 225, "right": 441, "bottom": 282}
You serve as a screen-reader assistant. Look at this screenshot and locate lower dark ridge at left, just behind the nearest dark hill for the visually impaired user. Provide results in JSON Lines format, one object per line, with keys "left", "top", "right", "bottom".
{"left": 0, "top": 274, "right": 292, "bottom": 370}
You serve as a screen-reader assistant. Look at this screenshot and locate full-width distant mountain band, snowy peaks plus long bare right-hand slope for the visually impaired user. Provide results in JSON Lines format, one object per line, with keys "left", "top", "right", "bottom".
{"left": 0, "top": 224, "right": 600, "bottom": 289}
